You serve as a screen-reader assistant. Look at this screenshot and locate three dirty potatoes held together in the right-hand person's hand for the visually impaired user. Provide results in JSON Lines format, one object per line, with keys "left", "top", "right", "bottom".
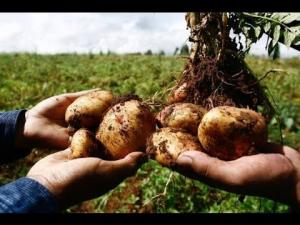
{"left": 147, "top": 103, "right": 267, "bottom": 167}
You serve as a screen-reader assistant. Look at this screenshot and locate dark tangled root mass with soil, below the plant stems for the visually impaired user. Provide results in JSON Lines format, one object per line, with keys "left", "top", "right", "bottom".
{"left": 171, "top": 54, "right": 273, "bottom": 118}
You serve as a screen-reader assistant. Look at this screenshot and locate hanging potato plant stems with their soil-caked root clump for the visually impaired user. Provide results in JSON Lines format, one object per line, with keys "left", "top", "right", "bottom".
{"left": 169, "top": 13, "right": 274, "bottom": 119}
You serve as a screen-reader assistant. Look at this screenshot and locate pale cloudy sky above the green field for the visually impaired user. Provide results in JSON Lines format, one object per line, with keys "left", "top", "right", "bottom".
{"left": 0, "top": 13, "right": 300, "bottom": 57}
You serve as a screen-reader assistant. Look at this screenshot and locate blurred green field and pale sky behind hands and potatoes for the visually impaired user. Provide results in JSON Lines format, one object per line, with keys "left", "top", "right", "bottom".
{"left": 0, "top": 13, "right": 300, "bottom": 213}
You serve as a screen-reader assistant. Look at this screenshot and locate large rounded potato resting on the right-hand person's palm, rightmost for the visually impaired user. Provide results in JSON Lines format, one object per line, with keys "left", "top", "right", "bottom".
{"left": 198, "top": 106, "right": 268, "bottom": 160}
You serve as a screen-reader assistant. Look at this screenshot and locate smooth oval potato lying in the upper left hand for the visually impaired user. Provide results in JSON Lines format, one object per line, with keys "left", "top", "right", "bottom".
{"left": 65, "top": 91, "right": 114, "bottom": 130}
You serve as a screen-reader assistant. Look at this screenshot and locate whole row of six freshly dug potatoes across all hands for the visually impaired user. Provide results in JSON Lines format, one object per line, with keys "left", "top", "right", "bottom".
{"left": 66, "top": 91, "right": 267, "bottom": 167}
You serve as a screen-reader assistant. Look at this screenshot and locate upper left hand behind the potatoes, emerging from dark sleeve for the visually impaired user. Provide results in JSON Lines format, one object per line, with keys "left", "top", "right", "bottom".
{"left": 15, "top": 89, "right": 97, "bottom": 149}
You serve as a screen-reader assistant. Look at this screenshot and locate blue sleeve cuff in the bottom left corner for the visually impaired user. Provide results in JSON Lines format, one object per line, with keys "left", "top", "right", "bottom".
{"left": 0, "top": 178, "right": 58, "bottom": 213}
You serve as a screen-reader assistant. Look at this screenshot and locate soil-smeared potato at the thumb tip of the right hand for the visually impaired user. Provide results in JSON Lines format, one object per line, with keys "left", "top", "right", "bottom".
{"left": 146, "top": 127, "right": 202, "bottom": 167}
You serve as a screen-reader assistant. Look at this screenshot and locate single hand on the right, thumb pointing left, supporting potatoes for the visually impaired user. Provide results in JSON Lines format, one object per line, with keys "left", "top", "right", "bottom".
{"left": 175, "top": 143, "right": 300, "bottom": 208}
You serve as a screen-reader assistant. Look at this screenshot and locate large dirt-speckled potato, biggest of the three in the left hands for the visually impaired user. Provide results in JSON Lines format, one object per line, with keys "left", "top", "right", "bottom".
{"left": 96, "top": 100, "right": 155, "bottom": 159}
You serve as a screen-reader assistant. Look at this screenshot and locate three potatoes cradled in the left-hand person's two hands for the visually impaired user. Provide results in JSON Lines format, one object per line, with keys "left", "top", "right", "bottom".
{"left": 65, "top": 91, "right": 155, "bottom": 160}
